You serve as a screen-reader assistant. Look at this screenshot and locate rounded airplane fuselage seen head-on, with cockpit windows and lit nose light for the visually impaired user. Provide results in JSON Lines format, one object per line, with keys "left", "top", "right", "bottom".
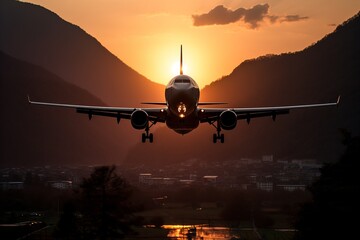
{"left": 165, "top": 74, "right": 200, "bottom": 134}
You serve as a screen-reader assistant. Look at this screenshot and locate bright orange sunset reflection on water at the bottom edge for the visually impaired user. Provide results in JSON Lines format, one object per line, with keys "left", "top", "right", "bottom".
{"left": 163, "top": 225, "right": 240, "bottom": 240}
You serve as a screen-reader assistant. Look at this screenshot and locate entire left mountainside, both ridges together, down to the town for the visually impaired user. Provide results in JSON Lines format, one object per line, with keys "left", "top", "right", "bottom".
{"left": 0, "top": 0, "right": 164, "bottom": 165}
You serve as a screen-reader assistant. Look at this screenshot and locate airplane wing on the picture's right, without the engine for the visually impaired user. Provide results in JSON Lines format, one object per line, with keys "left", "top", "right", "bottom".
{"left": 199, "top": 96, "right": 340, "bottom": 123}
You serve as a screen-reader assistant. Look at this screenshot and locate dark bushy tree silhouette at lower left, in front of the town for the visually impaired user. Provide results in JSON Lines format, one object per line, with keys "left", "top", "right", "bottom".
{"left": 81, "top": 166, "right": 133, "bottom": 239}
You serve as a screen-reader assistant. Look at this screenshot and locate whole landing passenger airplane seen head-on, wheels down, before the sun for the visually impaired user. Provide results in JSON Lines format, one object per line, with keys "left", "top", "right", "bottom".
{"left": 28, "top": 45, "right": 340, "bottom": 143}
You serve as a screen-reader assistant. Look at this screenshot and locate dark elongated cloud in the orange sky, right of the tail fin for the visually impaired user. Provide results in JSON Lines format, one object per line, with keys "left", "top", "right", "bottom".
{"left": 192, "top": 3, "right": 308, "bottom": 29}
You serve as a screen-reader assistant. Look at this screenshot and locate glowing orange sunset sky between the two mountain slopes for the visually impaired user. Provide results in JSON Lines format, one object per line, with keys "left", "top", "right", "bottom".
{"left": 26, "top": 0, "right": 360, "bottom": 87}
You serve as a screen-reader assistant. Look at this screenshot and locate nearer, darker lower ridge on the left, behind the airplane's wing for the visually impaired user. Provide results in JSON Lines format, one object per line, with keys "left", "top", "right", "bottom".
{"left": 0, "top": 51, "right": 135, "bottom": 167}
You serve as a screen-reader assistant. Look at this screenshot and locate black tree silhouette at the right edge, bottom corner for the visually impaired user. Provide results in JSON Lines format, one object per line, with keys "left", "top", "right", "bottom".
{"left": 296, "top": 133, "right": 360, "bottom": 240}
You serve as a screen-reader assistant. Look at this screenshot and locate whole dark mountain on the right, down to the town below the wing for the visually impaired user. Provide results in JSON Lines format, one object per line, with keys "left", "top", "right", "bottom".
{"left": 127, "top": 14, "right": 360, "bottom": 166}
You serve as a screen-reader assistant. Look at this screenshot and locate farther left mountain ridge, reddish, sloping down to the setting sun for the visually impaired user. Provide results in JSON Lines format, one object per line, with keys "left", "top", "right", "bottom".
{"left": 0, "top": 0, "right": 164, "bottom": 106}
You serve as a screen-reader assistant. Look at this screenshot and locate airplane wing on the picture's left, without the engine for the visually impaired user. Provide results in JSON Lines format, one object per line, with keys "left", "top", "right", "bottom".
{"left": 28, "top": 96, "right": 166, "bottom": 123}
